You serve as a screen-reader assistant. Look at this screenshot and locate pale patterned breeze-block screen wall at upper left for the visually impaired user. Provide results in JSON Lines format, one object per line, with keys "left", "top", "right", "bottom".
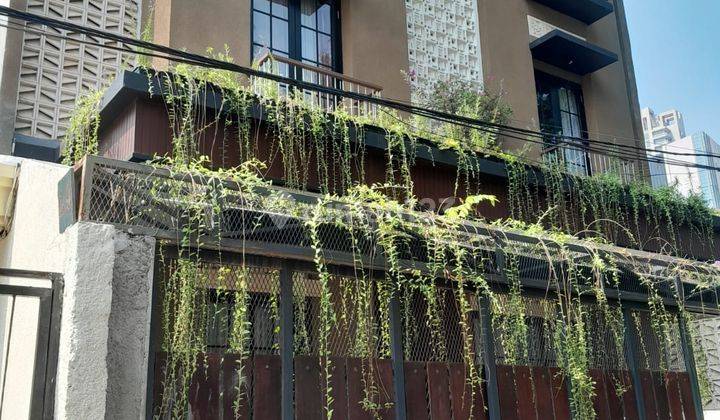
{"left": 15, "top": 0, "right": 140, "bottom": 139}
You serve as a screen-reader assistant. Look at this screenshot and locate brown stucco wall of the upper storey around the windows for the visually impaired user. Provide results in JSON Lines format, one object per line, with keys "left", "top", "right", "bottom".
{"left": 146, "top": 0, "right": 641, "bottom": 164}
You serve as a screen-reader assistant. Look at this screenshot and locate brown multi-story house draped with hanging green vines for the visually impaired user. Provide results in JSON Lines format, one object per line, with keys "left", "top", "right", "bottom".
{"left": 0, "top": 0, "right": 720, "bottom": 420}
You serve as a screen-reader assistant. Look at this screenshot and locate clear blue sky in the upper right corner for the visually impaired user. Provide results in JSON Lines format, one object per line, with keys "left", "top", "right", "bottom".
{"left": 624, "top": 0, "right": 720, "bottom": 141}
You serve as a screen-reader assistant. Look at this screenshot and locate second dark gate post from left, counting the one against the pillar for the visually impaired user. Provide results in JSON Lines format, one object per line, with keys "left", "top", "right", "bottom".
{"left": 280, "top": 261, "right": 295, "bottom": 420}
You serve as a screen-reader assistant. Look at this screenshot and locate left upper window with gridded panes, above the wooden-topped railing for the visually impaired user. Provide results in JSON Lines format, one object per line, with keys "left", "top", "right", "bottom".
{"left": 252, "top": 0, "right": 341, "bottom": 72}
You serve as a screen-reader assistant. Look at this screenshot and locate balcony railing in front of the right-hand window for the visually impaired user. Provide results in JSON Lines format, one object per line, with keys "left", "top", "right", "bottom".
{"left": 542, "top": 140, "right": 643, "bottom": 184}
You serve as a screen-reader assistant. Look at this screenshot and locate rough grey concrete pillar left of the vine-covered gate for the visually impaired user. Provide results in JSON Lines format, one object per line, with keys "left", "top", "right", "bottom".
{"left": 55, "top": 222, "right": 155, "bottom": 420}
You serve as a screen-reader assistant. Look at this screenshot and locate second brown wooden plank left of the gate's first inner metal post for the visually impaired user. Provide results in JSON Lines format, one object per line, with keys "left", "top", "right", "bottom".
{"left": 222, "top": 354, "right": 252, "bottom": 419}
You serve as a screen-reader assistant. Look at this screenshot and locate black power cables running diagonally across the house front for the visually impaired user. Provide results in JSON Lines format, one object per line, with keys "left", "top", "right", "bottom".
{"left": 0, "top": 6, "right": 720, "bottom": 170}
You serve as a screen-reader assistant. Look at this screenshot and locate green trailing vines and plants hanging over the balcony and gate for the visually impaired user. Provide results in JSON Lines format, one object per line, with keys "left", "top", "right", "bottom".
{"left": 65, "top": 50, "right": 717, "bottom": 418}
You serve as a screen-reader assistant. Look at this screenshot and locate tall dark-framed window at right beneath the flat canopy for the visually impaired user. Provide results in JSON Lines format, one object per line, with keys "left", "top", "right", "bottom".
{"left": 535, "top": 72, "right": 590, "bottom": 175}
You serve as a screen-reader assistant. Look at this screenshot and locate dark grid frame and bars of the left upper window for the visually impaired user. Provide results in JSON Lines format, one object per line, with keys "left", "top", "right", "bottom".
{"left": 250, "top": 0, "right": 342, "bottom": 73}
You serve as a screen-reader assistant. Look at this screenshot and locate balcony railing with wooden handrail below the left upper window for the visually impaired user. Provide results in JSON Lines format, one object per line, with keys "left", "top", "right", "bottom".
{"left": 253, "top": 52, "right": 382, "bottom": 117}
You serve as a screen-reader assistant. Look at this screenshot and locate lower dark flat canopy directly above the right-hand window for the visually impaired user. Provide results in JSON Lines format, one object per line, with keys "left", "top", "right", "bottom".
{"left": 530, "top": 29, "right": 618, "bottom": 76}
